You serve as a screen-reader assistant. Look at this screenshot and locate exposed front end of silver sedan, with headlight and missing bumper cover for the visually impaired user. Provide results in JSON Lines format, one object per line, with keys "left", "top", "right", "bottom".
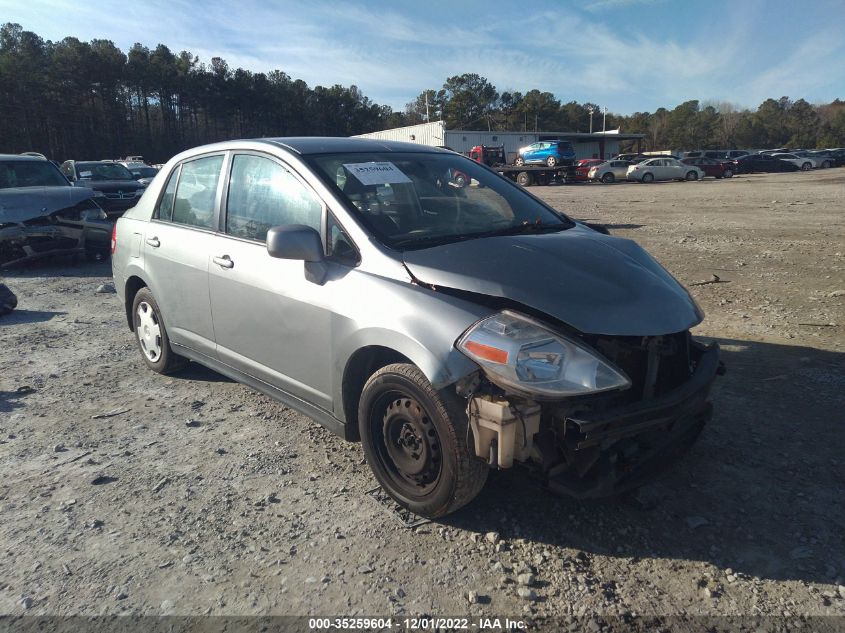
{"left": 457, "top": 310, "right": 724, "bottom": 498}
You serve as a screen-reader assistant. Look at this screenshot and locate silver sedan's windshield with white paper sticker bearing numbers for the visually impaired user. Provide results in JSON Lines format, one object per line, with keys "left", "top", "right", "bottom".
{"left": 310, "top": 152, "right": 574, "bottom": 250}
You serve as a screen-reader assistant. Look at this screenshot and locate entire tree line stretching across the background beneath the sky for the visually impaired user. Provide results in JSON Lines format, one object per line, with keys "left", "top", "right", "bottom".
{"left": 0, "top": 23, "right": 845, "bottom": 162}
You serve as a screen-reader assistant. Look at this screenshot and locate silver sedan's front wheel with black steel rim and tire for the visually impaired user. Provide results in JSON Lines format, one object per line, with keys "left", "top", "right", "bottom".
{"left": 358, "top": 364, "right": 489, "bottom": 519}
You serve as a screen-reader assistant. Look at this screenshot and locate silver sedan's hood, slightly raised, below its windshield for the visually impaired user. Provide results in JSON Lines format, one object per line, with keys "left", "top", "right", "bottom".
{"left": 403, "top": 226, "right": 704, "bottom": 336}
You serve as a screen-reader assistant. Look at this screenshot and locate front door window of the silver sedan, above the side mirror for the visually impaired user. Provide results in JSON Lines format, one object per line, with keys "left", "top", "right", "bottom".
{"left": 226, "top": 154, "right": 323, "bottom": 242}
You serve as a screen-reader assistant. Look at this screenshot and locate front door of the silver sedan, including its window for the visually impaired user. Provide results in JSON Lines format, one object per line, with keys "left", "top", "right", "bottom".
{"left": 209, "top": 152, "right": 332, "bottom": 410}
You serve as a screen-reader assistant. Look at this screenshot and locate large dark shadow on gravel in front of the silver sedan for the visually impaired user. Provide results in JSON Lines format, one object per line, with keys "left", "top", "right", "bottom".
{"left": 443, "top": 340, "right": 845, "bottom": 583}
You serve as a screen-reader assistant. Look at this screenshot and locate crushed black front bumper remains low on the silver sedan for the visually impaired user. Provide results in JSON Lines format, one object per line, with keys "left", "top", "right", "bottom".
{"left": 545, "top": 343, "right": 724, "bottom": 499}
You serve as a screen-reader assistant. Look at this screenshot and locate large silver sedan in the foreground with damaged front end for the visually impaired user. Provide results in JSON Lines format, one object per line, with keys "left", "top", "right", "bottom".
{"left": 112, "top": 138, "right": 721, "bottom": 517}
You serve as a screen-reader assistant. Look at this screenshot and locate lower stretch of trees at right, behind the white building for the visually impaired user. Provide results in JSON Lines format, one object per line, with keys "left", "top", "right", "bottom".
{"left": 403, "top": 74, "right": 845, "bottom": 149}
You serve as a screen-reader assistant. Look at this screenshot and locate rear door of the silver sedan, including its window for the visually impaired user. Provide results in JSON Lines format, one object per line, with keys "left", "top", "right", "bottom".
{"left": 143, "top": 153, "right": 225, "bottom": 357}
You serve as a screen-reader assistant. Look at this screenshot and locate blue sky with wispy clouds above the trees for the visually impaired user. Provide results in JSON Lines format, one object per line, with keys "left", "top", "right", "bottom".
{"left": 0, "top": 0, "right": 845, "bottom": 114}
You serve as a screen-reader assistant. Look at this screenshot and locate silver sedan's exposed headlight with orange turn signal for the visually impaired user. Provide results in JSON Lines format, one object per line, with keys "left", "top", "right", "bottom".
{"left": 456, "top": 310, "right": 631, "bottom": 397}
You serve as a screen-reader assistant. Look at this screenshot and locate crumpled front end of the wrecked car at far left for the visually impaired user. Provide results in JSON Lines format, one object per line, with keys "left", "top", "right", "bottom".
{"left": 0, "top": 196, "right": 112, "bottom": 268}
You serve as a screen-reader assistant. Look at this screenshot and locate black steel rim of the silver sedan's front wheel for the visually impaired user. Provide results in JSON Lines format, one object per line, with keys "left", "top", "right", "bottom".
{"left": 370, "top": 391, "right": 443, "bottom": 497}
